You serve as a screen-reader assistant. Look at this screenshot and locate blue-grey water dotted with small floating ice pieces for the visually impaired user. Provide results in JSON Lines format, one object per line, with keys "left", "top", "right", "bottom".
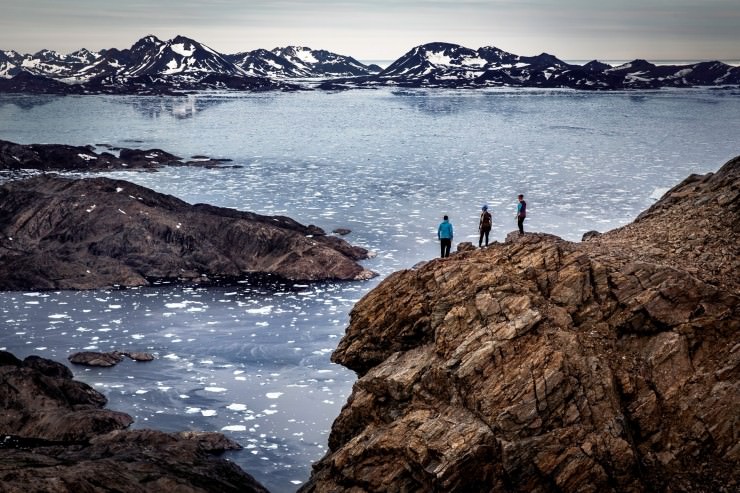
{"left": 0, "top": 89, "right": 740, "bottom": 492}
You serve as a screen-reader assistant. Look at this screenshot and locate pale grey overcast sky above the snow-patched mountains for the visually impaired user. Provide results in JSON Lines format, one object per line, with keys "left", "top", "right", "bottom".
{"left": 0, "top": 0, "right": 740, "bottom": 60}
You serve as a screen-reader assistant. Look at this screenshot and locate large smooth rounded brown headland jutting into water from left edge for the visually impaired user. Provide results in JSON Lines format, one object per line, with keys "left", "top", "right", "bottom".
{"left": 0, "top": 176, "right": 373, "bottom": 290}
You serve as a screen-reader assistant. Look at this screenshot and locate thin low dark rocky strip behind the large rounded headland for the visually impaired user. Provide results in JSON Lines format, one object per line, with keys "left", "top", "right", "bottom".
{"left": 0, "top": 140, "right": 227, "bottom": 171}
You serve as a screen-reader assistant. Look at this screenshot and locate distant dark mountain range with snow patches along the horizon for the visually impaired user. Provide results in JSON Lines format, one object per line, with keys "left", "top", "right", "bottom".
{"left": 0, "top": 36, "right": 740, "bottom": 94}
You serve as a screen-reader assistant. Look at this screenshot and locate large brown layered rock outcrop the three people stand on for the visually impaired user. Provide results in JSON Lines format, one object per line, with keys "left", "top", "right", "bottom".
{"left": 301, "top": 158, "right": 740, "bottom": 492}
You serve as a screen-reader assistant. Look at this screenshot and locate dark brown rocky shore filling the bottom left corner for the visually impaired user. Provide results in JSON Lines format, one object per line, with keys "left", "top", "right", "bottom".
{"left": 0, "top": 351, "right": 267, "bottom": 493}
